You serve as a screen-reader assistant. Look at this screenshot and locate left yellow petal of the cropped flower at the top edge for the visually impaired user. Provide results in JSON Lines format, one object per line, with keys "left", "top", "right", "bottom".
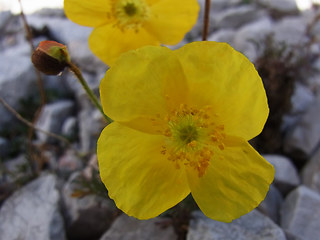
{"left": 64, "top": 0, "right": 111, "bottom": 27}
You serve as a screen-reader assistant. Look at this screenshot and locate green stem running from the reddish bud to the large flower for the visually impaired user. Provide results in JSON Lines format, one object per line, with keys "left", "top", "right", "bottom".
{"left": 68, "top": 62, "right": 113, "bottom": 123}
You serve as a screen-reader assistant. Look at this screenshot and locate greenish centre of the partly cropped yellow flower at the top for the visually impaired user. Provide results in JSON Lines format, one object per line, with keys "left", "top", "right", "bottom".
{"left": 112, "top": 0, "right": 149, "bottom": 31}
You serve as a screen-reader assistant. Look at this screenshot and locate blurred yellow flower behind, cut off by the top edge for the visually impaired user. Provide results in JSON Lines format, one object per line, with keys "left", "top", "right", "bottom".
{"left": 64, "top": 0, "right": 199, "bottom": 64}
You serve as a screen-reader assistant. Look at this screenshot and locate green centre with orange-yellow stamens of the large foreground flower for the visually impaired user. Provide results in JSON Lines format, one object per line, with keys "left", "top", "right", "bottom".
{"left": 161, "top": 104, "right": 225, "bottom": 177}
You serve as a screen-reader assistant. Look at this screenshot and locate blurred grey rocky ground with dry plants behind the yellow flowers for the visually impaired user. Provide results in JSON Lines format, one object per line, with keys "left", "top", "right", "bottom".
{"left": 0, "top": 0, "right": 320, "bottom": 240}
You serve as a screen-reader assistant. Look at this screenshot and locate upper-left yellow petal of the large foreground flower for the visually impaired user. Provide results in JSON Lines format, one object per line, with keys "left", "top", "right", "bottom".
{"left": 100, "top": 46, "right": 187, "bottom": 133}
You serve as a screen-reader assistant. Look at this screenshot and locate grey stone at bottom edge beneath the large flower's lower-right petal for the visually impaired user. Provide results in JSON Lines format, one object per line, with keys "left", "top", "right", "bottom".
{"left": 187, "top": 210, "right": 286, "bottom": 240}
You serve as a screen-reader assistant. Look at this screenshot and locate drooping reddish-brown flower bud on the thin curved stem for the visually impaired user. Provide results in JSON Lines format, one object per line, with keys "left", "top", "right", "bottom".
{"left": 31, "top": 41, "right": 70, "bottom": 75}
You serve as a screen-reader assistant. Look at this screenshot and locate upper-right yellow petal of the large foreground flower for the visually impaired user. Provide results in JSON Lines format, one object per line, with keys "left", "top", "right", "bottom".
{"left": 174, "top": 42, "right": 269, "bottom": 140}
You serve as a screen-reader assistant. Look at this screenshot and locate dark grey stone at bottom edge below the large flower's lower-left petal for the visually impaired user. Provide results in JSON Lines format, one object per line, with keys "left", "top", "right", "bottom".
{"left": 100, "top": 214, "right": 177, "bottom": 240}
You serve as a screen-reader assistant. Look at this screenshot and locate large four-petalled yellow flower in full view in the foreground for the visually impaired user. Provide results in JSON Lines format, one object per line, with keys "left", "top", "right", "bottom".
{"left": 98, "top": 42, "right": 274, "bottom": 222}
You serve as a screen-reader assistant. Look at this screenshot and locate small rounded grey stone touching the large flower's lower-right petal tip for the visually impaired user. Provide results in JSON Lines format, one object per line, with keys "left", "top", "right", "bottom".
{"left": 263, "top": 155, "right": 300, "bottom": 195}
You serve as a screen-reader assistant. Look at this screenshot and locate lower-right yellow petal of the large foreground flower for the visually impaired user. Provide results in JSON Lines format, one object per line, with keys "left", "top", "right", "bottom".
{"left": 188, "top": 136, "right": 274, "bottom": 222}
